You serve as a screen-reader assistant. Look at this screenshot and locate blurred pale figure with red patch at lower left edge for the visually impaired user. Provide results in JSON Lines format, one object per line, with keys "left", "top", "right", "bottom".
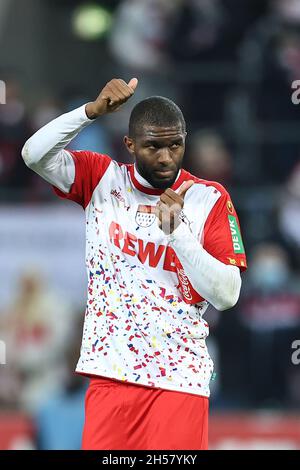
{"left": 0, "top": 269, "right": 74, "bottom": 411}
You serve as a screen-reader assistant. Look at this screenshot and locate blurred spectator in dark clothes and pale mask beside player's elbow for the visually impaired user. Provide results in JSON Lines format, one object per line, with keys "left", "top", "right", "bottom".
{"left": 240, "top": 243, "right": 300, "bottom": 407}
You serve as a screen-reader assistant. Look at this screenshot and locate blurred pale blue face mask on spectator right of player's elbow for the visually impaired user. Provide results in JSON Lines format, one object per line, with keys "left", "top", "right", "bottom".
{"left": 250, "top": 258, "right": 289, "bottom": 290}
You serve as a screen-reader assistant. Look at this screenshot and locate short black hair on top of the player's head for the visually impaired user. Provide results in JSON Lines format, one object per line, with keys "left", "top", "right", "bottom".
{"left": 129, "top": 96, "right": 186, "bottom": 137}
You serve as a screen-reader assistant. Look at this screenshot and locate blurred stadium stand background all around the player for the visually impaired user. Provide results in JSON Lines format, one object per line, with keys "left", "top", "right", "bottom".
{"left": 0, "top": 0, "right": 300, "bottom": 449}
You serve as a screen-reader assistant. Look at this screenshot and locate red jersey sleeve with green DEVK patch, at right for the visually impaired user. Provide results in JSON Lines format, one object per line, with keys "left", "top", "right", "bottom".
{"left": 203, "top": 185, "right": 247, "bottom": 271}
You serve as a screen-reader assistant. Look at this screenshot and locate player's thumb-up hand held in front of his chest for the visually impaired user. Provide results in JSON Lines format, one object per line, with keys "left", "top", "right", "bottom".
{"left": 155, "top": 180, "right": 194, "bottom": 235}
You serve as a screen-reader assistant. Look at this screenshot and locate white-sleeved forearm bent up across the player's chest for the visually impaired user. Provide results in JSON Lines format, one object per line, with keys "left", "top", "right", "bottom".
{"left": 169, "top": 222, "right": 242, "bottom": 310}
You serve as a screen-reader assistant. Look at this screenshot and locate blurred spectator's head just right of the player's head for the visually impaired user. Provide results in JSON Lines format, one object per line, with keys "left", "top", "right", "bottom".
{"left": 188, "top": 130, "right": 233, "bottom": 187}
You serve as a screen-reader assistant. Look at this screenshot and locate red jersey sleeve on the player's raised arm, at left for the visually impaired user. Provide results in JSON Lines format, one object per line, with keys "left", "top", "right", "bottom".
{"left": 53, "top": 150, "right": 112, "bottom": 209}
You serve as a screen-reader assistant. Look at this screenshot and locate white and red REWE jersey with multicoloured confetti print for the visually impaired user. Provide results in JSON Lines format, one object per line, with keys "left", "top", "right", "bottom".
{"left": 55, "top": 152, "right": 246, "bottom": 396}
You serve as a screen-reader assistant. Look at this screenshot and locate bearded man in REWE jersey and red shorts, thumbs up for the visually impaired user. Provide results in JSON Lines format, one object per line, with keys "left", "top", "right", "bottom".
{"left": 22, "top": 78, "right": 246, "bottom": 450}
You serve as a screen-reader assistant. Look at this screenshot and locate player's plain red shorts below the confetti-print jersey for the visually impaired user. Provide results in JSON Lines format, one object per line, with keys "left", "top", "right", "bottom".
{"left": 82, "top": 377, "right": 209, "bottom": 450}
